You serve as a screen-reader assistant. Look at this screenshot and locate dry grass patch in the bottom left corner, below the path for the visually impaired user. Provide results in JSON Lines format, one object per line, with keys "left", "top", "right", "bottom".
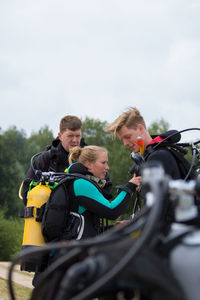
{"left": 0, "top": 278, "right": 32, "bottom": 300}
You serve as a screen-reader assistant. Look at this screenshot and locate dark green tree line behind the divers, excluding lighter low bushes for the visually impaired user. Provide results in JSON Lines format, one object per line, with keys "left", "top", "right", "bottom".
{"left": 0, "top": 118, "right": 169, "bottom": 218}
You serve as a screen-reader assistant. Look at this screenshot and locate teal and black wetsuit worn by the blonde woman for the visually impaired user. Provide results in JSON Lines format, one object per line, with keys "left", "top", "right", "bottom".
{"left": 68, "top": 163, "right": 136, "bottom": 238}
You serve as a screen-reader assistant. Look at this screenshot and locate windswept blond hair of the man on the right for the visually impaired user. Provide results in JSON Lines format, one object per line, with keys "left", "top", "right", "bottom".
{"left": 105, "top": 107, "right": 146, "bottom": 136}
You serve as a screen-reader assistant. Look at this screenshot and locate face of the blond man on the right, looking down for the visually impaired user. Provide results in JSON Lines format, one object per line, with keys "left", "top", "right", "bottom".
{"left": 117, "top": 125, "right": 141, "bottom": 153}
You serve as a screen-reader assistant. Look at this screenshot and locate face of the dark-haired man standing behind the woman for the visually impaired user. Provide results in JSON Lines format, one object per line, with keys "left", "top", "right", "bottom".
{"left": 58, "top": 129, "right": 81, "bottom": 152}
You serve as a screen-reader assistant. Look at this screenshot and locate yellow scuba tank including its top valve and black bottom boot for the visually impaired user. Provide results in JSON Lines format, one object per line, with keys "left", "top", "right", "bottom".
{"left": 19, "top": 170, "right": 66, "bottom": 272}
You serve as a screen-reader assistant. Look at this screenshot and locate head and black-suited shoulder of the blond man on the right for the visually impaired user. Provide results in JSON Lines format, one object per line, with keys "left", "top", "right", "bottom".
{"left": 105, "top": 108, "right": 181, "bottom": 179}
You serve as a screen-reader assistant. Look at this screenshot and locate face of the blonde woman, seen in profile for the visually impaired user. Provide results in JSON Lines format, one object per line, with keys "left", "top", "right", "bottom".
{"left": 86, "top": 151, "right": 109, "bottom": 180}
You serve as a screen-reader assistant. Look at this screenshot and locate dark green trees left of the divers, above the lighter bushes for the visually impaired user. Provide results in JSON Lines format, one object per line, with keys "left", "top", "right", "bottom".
{"left": 0, "top": 126, "right": 53, "bottom": 218}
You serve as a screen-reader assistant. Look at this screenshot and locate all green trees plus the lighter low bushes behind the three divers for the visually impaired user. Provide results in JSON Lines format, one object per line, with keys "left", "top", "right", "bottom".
{"left": 0, "top": 118, "right": 189, "bottom": 260}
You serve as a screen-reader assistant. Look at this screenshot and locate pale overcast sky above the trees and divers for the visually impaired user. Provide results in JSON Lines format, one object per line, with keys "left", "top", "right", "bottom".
{"left": 0, "top": 0, "right": 200, "bottom": 141}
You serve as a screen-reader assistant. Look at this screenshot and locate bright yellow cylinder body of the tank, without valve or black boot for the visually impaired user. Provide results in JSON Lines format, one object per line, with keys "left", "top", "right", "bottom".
{"left": 22, "top": 183, "right": 51, "bottom": 247}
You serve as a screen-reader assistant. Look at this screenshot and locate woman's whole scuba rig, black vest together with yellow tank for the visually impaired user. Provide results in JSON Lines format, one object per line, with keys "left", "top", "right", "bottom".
{"left": 20, "top": 172, "right": 104, "bottom": 272}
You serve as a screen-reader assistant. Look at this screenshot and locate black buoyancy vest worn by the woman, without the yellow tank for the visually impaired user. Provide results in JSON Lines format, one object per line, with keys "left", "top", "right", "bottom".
{"left": 42, "top": 173, "right": 108, "bottom": 242}
